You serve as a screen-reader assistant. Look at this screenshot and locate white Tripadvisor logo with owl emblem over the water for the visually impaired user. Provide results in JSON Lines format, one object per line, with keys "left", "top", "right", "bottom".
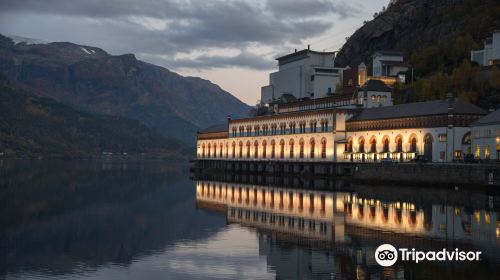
{"left": 375, "top": 244, "right": 482, "bottom": 266}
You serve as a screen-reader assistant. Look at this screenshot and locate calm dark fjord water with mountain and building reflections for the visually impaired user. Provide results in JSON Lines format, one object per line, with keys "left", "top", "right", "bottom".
{"left": 0, "top": 160, "right": 500, "bottom": 279}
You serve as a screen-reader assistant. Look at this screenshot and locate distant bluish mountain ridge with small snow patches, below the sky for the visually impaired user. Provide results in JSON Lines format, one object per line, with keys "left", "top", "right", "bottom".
{"left": 0, "top": 35, "right": 250, "bottom": 145}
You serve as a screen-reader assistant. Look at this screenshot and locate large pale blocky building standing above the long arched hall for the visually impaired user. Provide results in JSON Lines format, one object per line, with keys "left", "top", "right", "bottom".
{"left": 261, "top": 49, "right": 342, "bottom": 104}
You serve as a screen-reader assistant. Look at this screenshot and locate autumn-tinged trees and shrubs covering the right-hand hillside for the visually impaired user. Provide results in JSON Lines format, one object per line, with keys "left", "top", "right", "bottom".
{"left": 388, "top": 0, "right": 500, "bottom": 108}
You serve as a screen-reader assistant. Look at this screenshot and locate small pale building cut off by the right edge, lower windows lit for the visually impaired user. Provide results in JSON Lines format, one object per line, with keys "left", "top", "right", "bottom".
{"left": 472, "top": 110, "right": 500, "bottom": 161}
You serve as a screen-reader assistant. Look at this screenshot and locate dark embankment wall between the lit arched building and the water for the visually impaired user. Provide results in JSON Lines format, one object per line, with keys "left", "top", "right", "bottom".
{"left": 192, "top": 160, "right": 500, "bottom": 189}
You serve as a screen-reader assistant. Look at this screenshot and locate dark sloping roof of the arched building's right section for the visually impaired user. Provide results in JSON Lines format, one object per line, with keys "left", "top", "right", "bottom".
{"left": 349, "top": 99, "right": 486, "bottom": 121}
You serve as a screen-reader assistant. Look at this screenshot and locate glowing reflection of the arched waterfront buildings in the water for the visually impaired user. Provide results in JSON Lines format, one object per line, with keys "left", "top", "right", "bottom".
{"left": 196, "top": 180, "right": 500, "bottom": 279}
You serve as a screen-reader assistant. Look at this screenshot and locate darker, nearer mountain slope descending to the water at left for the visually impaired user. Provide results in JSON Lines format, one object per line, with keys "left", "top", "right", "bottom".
{"left": 0, "top": 77, "right": 190, "bottom": 158}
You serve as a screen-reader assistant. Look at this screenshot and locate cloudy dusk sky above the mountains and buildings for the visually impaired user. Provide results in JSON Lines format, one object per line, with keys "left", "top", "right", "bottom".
{"left": 0, "top": 0, "right": 389, "bottom": 105}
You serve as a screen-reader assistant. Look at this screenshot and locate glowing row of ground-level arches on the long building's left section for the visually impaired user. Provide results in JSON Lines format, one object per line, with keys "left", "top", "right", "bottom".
{"left": 200, "top": 138, "right": 328, "bottom": 159}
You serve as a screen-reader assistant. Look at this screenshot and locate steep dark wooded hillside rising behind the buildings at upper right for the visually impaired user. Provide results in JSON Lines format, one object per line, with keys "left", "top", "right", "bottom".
{"left": 335, "top": 0, "right": 500, "bottom": 109}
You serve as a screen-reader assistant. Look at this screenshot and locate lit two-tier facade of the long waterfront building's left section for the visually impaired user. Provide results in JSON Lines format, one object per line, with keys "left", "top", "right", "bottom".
{"left": 197, "top": 110, "right": 352, "bottom": 161}
